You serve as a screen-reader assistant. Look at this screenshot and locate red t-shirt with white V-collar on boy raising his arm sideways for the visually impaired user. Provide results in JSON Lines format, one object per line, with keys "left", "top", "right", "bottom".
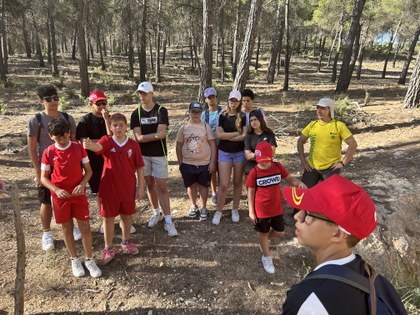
{"left": 96, "top": 136, "right": 144, "bottom": 202}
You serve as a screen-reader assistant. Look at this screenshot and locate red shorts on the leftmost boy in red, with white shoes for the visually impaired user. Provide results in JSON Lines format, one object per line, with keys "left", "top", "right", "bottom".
{"left": 52, "top": 194, "right": 90, "bottom": 224}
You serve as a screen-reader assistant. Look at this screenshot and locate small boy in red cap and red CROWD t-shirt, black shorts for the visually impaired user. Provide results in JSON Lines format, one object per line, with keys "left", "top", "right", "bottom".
{"left": 246, "top": 141, "right": 306, "bottom": 273}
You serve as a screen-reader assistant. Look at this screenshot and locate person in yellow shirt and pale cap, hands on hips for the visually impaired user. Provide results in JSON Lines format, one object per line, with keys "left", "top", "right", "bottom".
{"left": 297, "top": 98, "right": 357, "bottom": 188}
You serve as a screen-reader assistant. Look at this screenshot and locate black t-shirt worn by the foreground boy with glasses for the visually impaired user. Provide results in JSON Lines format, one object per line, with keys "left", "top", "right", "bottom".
{"left": 283, "top": 255, "right": 369, "bottom": 315}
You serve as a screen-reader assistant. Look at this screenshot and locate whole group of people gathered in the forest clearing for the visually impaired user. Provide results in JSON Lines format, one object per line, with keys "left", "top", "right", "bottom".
{"left": 23, "top": 82, "right": 406, "bottom": 314}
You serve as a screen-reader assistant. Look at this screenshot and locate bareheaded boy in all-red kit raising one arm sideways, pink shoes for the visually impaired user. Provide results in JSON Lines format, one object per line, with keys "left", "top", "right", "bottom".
{"left": 83, "top": 113, "right": 144, "bottom": 264}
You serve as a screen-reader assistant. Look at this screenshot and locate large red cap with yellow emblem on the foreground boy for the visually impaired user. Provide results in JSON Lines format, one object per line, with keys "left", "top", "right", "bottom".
{"left": 283, "top": 174, "right": 376, "bottom": 240}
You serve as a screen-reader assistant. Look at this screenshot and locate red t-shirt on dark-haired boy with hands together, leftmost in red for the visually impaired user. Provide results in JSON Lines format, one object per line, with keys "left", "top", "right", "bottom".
{"left": 41, "top": 142, "right": 89, "bottom": 194}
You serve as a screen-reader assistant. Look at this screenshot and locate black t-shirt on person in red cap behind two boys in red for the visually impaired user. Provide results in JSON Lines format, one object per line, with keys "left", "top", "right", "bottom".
{"left": 76, "top": 113, "right": 107, "bottom": 172}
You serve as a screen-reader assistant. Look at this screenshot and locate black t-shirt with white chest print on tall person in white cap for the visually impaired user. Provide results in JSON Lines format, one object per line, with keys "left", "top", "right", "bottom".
{"left": 130, "top": 103, "right": 169, "bottom": 156}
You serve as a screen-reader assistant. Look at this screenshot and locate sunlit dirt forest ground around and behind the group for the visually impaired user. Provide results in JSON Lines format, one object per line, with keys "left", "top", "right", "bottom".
{"left": 0, "top": 53, "right": 420, "bottom": 315}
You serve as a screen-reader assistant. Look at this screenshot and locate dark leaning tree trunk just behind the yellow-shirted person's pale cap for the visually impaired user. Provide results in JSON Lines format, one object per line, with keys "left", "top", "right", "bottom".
{"left": 335, "top": 0, "right": 366, "bottom": 94}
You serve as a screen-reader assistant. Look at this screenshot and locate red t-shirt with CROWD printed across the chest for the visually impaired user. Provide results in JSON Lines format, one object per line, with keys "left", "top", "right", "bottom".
{"left": 246, "top": 162, "right": 289, "bottom": 219}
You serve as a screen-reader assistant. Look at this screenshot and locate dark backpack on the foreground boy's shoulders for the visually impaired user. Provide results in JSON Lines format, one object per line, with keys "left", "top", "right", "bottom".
{"left": 304, "top": 262, "right": 407, "bottom": 315}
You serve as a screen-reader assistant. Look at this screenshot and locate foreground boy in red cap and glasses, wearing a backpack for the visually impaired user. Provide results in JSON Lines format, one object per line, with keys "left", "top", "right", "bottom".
{"left": 283, "top": 174, "right": 406, "bottom": 315}
